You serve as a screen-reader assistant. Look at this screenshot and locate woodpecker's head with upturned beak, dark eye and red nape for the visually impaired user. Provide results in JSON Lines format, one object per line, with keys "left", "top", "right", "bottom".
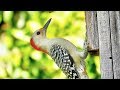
{"left": 30, "top": 18, "right": 52, "bottom": 53}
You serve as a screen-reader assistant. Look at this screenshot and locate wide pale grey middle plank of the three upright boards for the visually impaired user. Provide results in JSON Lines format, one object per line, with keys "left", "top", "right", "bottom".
{"left": 97, "top": 11, "right": 113, "bottom": 79}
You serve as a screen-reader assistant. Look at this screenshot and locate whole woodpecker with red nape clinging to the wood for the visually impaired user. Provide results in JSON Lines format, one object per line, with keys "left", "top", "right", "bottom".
{"left": 30, "top": 18, "right": 88, "bottom": 79}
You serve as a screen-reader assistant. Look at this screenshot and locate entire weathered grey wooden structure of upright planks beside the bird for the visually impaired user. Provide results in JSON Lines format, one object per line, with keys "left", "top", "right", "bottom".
{"left": 86, "top": 11, "right": 120, "bottom": 79}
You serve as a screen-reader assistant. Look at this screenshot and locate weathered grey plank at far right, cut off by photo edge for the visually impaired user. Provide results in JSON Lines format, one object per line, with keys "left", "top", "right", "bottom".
{"left": 109, "top": 11, "right": 120, "bottom": 79}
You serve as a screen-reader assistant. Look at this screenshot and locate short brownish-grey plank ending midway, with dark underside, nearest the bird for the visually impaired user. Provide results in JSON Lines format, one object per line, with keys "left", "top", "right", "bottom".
{"left": 85, "top": 11, "right": 99, "bottom": 55}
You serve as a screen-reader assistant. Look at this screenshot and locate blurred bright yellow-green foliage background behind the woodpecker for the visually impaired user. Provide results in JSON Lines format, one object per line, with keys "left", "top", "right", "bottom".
{"left": 0, "top": 11, "right": 100, "bottom": 79}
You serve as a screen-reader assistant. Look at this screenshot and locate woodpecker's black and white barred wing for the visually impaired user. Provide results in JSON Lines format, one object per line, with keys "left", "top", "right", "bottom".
{"left": 50, "top": 45, "right": 80, "bottom": 79}
